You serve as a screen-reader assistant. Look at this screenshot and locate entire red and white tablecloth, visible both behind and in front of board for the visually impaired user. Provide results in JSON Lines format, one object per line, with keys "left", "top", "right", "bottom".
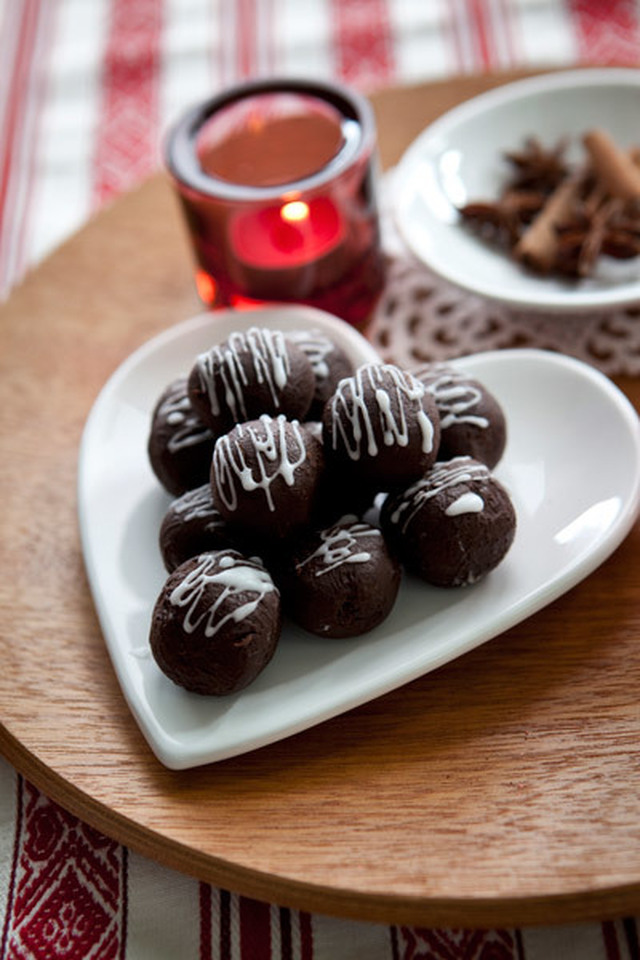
{"left": 0, "top": 0, "right": 640, "bottom": 960}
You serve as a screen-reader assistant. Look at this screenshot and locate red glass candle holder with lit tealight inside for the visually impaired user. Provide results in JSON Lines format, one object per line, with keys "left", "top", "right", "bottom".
{"left": 166, "top": 79, "right": 385, "bottom": 327}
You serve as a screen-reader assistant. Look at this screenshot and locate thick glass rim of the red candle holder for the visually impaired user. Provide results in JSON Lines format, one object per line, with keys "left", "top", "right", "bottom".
{"left": 164, "top": 77, "right": 376, "bottom": 203}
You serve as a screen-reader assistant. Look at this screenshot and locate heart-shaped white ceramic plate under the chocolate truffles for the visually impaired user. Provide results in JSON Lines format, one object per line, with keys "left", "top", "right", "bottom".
{"left": 79, "top": 307, "right": 640, "bottom": 768}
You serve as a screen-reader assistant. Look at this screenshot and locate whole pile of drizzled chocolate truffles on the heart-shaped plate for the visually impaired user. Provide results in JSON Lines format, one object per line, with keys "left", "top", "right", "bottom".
{"left": 148, "top": 326, "right": 516, "bottom": 696}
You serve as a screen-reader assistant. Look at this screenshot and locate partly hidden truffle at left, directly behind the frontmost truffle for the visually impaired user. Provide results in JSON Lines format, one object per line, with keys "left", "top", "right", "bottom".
{"left": 159, "top": 483, "right": 238, "bottom": 571}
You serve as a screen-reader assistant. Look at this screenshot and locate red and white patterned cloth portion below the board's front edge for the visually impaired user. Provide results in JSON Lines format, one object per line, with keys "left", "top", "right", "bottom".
{"left": 0, "top": 760, "right": 639, "bottom": 960}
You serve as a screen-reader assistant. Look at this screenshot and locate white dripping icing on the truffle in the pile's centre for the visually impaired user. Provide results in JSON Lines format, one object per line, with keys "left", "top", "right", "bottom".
{"left": 213, "top": 414, "right": 307, "bottom": 511}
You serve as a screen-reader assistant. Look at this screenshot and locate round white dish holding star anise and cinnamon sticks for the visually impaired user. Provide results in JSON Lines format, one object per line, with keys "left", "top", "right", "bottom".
{"left": 392, "top": 68, "right": 640, "bottom": 312}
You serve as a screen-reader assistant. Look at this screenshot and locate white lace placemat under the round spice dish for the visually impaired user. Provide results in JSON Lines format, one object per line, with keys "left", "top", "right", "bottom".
{"left": 367, "top": 177, "right": 640, "bottom": 376}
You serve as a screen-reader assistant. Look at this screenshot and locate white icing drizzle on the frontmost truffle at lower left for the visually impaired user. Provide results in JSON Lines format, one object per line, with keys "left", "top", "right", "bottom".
{"left": 169, "top": 553, "right": 276, "bottom": 637}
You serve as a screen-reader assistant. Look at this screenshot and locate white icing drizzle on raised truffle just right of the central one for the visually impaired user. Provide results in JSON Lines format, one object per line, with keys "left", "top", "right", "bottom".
{"left": 331, "top": 364, "right": 434, "bottom": 460}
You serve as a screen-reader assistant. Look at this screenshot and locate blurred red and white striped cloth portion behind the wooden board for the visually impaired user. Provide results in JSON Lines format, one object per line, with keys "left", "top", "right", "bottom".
{"left": 0, "top": 0, "right": 640, "bottom": 296}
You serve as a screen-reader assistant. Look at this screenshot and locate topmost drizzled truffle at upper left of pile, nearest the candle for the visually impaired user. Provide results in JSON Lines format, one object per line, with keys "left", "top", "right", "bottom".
{"left": 188, "top": 327, "right": 315, "bottom": 435}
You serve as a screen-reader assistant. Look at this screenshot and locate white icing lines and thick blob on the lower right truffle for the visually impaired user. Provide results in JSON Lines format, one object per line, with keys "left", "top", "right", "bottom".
{"left": 390, "top": 457, "right": 490, "bottom": 532}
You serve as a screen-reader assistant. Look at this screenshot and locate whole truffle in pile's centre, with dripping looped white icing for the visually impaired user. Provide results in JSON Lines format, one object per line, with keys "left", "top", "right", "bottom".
{"left": 211, "top": 414, "right": 324, "bottom": 538}
